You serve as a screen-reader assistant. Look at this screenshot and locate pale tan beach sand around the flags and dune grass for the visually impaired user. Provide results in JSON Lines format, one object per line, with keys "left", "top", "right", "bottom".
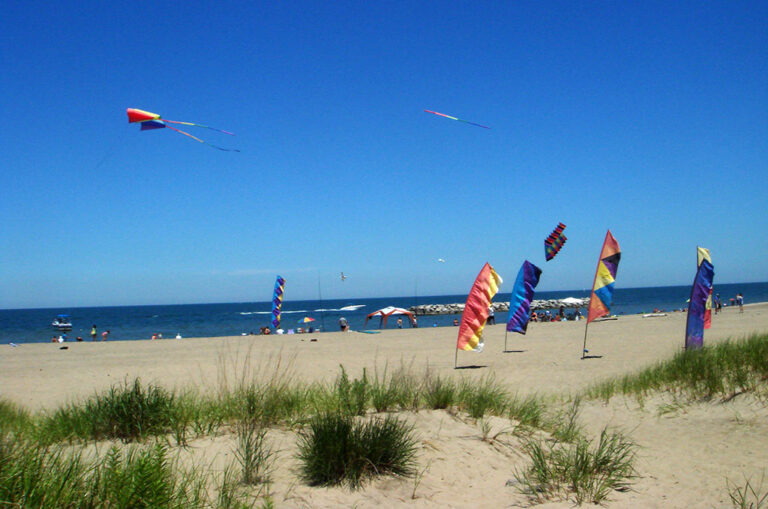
{"left": 0, "top": 303, "right": 768, "bottom": 507}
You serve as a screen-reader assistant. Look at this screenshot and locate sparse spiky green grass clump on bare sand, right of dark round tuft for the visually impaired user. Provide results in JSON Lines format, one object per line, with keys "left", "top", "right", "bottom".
{"left": 515, "top": 429, "right": 636, "bottom": 505}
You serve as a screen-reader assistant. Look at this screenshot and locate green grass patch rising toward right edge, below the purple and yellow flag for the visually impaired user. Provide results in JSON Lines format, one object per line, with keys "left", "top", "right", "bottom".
{"left": 586, "top": 333, "right": 768, "bottom": 401}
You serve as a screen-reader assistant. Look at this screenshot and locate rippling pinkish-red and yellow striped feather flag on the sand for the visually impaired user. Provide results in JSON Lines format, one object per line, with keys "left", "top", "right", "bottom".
{"left": 456, "top": 263, "right": 503, "bottom": 355}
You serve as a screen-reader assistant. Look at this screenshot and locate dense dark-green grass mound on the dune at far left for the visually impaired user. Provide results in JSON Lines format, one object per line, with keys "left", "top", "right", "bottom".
{"left": 39, "top": 378, "right": 182, "bottom": 442}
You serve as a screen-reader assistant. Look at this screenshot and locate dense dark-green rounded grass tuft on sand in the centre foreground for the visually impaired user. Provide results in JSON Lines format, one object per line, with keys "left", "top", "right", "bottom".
{"left": 298, "top": 413, "right": 416, "bottom": 489}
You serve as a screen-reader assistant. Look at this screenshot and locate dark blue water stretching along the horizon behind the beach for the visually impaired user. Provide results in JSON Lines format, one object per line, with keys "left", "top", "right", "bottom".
{"left": 0, "top": 283, "right": 768, "bottom": 343}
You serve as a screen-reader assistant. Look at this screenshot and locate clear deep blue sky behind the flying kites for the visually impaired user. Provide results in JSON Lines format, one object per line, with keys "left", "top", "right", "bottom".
{"left": 0, "top": 1, "right": 768, "bottom": 308}
